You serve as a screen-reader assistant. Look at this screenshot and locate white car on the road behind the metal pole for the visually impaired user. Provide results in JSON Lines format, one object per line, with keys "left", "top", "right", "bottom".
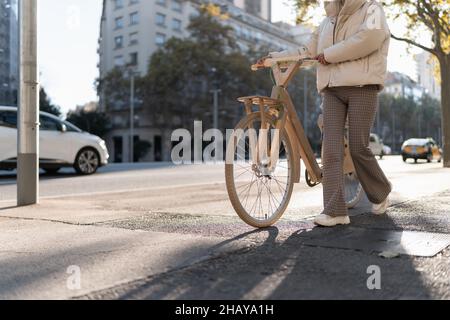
{"left": 0, "top": 107, "right": 109, "bottom": 175}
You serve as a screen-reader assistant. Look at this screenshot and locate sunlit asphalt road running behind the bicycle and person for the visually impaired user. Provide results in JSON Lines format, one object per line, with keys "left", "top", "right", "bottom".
{"left": 0, "top": 156, "right": 448, "bottom": 215}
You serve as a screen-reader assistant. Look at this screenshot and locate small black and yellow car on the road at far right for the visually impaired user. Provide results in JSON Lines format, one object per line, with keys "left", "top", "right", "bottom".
{"left": 402, "top": 138, "right": 442, "bottom": 163}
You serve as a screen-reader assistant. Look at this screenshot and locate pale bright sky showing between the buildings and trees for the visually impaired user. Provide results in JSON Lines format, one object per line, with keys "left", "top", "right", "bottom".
{"left": 38, "top": 0, "right": 422, "bottom": 113}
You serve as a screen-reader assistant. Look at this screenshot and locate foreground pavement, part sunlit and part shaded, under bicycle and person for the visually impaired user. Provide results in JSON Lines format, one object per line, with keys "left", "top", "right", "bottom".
{"left": 0, "top": 184, "right": 450, "bottom": 299}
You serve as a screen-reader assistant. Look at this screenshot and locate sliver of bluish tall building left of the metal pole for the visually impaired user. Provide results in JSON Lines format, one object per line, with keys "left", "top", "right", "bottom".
{"left": 0, "top": 0, "right": 19, "bottom": 106}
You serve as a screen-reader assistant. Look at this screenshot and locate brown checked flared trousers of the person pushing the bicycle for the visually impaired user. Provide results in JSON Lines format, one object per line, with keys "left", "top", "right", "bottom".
{"left": 322, "top": 85, "right": 392, "bottom": 216}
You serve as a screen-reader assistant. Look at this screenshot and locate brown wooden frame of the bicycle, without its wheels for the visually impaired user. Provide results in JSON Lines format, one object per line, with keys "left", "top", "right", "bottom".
{"left": 239, "top": 59, "right": 355, "bottom": 185}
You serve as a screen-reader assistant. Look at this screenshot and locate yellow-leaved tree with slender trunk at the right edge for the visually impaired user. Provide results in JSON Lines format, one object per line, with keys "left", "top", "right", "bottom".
{"left": 293, "top": 0, "right": 450, "bottom": 167}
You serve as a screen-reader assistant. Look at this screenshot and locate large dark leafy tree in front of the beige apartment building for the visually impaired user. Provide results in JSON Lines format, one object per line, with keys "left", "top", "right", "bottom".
{"left": 143, "top": 10, "right": 270, "bottom": 129}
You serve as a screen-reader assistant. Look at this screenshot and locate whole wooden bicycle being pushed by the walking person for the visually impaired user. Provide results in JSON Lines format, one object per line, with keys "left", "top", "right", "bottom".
{"left": 225, "top": 58, "right": 363, "bottom": 228}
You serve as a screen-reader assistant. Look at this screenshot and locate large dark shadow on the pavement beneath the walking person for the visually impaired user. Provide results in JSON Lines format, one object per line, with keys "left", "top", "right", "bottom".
{"left": 82, "top": 216, "right": 431, "bottom": 300}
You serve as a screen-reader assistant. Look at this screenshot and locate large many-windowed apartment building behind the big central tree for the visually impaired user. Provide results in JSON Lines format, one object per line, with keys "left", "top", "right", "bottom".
{"left": 99, "top": 0, "right": 310, "bottom": 162}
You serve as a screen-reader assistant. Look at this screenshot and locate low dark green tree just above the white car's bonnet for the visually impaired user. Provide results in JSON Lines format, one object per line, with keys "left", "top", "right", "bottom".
{"left": 66, "top": 110, "right": 111, "bottom": 138}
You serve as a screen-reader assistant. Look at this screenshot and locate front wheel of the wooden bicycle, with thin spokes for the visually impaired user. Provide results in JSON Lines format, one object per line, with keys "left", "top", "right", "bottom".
{"left": 225, "top": 113, "right": 294, "bottom": 228}
